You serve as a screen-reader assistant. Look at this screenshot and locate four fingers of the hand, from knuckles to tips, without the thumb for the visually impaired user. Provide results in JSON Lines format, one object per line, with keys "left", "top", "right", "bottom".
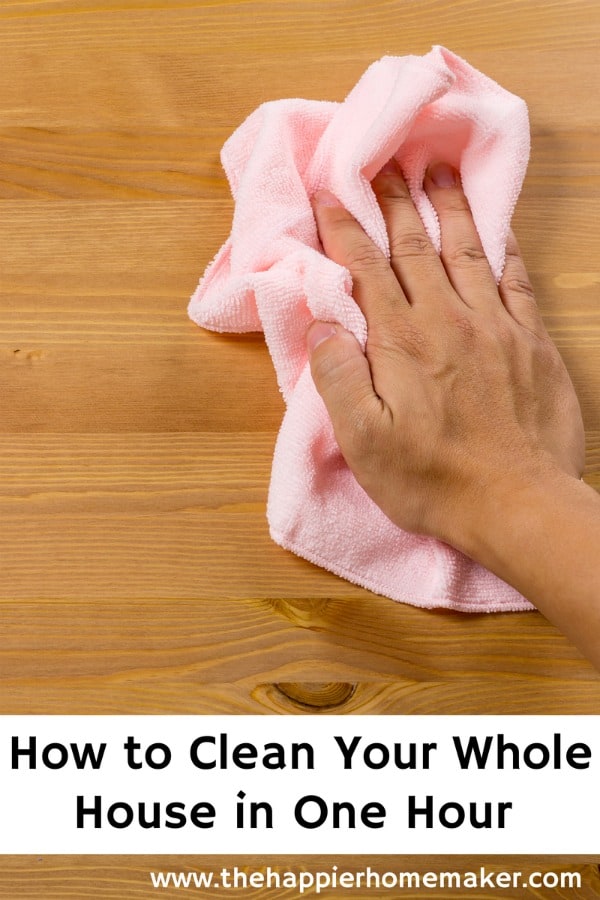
{"left": 313, "top": 160, "right": 532, "bottom": 331}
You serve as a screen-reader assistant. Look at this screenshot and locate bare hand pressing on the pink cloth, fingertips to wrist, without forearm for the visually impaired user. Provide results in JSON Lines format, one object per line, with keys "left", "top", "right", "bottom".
{"left": 307, "top": 164, "right": 584, "bottom": 552}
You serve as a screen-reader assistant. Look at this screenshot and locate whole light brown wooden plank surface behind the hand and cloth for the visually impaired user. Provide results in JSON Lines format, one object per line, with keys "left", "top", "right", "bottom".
{"left": 0, "top": 0, "right": 600, "bottom": 900}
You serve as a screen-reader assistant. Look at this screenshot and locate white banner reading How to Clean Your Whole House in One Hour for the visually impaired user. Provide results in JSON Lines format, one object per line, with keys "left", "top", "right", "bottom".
{"left": 0, "top": 716, "right": 600, "bottom": 855}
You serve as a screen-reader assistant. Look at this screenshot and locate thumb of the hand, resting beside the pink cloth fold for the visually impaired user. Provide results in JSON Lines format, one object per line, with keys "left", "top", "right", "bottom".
{"left": 306, "top": 321, "right": 378, "bottom": 438}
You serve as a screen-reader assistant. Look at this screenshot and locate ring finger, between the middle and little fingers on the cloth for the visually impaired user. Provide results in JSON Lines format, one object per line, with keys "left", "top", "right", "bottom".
{"left": 423, "top": 163, "right": 498, "bottom": 309}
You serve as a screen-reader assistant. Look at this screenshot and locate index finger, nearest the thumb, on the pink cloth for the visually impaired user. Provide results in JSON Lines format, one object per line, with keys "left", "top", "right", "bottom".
{"left": 312, "top": 191, "right": 407, "bottom": 320}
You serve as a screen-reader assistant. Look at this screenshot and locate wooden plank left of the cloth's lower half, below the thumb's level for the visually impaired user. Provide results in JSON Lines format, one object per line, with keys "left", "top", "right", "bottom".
{"left": 0, "top": 433, "right": 598, "bottom": 600}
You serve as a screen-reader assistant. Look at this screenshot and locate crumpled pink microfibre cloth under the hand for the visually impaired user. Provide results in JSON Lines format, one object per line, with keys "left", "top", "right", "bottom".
{"left": 189, "top": 46, "right": 530, "bottom": 612}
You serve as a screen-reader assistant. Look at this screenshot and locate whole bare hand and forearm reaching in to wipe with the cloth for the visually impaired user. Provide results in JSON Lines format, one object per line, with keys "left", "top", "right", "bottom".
{"left": 308, "top": 162, "right": 600, "bottom": 669}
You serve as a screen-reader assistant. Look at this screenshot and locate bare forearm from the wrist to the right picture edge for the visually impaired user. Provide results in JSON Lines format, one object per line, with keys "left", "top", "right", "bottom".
{"left": 463, "top": 466, "right": 600, "bottom": 669}
